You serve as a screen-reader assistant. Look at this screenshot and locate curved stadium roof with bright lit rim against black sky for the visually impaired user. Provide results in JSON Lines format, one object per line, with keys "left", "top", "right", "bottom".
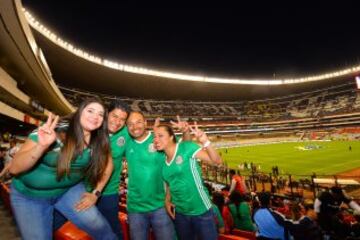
{"left": 21, "top": 1, "right": 360, "bottom": 100}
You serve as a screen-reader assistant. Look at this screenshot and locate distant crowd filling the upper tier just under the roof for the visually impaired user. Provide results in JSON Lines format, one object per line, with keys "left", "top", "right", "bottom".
{"left": 60, "top": 83, "right": 360, "bottom": 121}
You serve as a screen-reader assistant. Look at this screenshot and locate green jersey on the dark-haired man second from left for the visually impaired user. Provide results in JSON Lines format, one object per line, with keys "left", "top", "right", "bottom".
{"left": 102, "top": 127, "right": 130, "bottom": 195}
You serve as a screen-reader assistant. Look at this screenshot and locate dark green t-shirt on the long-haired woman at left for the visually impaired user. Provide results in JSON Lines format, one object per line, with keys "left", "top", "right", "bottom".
{"left": 12, "top": 131, "right": 90, "bottom": 197}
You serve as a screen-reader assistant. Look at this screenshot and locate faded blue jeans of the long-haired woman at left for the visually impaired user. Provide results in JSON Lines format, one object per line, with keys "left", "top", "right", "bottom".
{"left": 10, "top": 183, "right": 116, "bottom": 240}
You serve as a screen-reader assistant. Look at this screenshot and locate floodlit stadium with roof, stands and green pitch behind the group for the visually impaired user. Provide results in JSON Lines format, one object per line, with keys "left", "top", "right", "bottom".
{"left": 0, "top": 0, "right": 360, "bottom": 240}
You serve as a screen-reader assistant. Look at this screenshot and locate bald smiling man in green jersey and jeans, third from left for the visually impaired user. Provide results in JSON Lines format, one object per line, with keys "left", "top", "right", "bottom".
{"left": 126, "top": 112, "right": 175, "bottom": 240}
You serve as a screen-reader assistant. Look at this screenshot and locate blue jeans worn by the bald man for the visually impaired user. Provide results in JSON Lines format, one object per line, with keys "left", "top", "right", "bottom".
{"left": 128, "top": 208, "right": 175, "bottom": 240}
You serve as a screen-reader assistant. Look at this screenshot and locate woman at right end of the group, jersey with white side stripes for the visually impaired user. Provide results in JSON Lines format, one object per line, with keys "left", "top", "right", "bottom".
{"left": 154, "top": 123, "right": 222, "bottom": 240}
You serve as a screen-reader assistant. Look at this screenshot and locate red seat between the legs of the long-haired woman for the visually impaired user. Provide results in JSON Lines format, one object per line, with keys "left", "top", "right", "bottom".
{"left": 54, "top": 221, "right": 92, "bottom": 240}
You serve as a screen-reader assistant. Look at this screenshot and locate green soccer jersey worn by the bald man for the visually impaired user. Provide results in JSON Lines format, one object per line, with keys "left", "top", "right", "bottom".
{"left": 125, "top": 132, "right": 165, "bottom": 213}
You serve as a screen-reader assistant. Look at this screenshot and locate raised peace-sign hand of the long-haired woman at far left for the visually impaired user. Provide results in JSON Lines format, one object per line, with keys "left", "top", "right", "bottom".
{"left": 38, "top": 113, "right": 59, "bottom": 147}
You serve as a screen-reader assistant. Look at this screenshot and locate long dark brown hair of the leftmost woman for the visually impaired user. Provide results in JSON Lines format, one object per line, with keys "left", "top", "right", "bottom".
{"left": 57, "top": 98, "right": 110, "bottom": 186}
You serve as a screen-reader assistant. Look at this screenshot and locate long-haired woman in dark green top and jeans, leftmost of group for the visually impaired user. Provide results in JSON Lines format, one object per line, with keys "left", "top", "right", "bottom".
{"left": 10, "top": 99, "right": 116, "bottom": 240}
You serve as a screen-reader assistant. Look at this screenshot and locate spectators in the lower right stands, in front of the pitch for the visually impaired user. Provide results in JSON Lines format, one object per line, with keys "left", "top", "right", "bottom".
{"left": 208, "top": 181, "right": 360, "bottom": 240}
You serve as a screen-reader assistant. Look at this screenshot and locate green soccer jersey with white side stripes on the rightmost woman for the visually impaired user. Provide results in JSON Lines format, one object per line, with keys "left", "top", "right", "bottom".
{"left": 162, "top": 141, "right": 211, "bottom": 216}
